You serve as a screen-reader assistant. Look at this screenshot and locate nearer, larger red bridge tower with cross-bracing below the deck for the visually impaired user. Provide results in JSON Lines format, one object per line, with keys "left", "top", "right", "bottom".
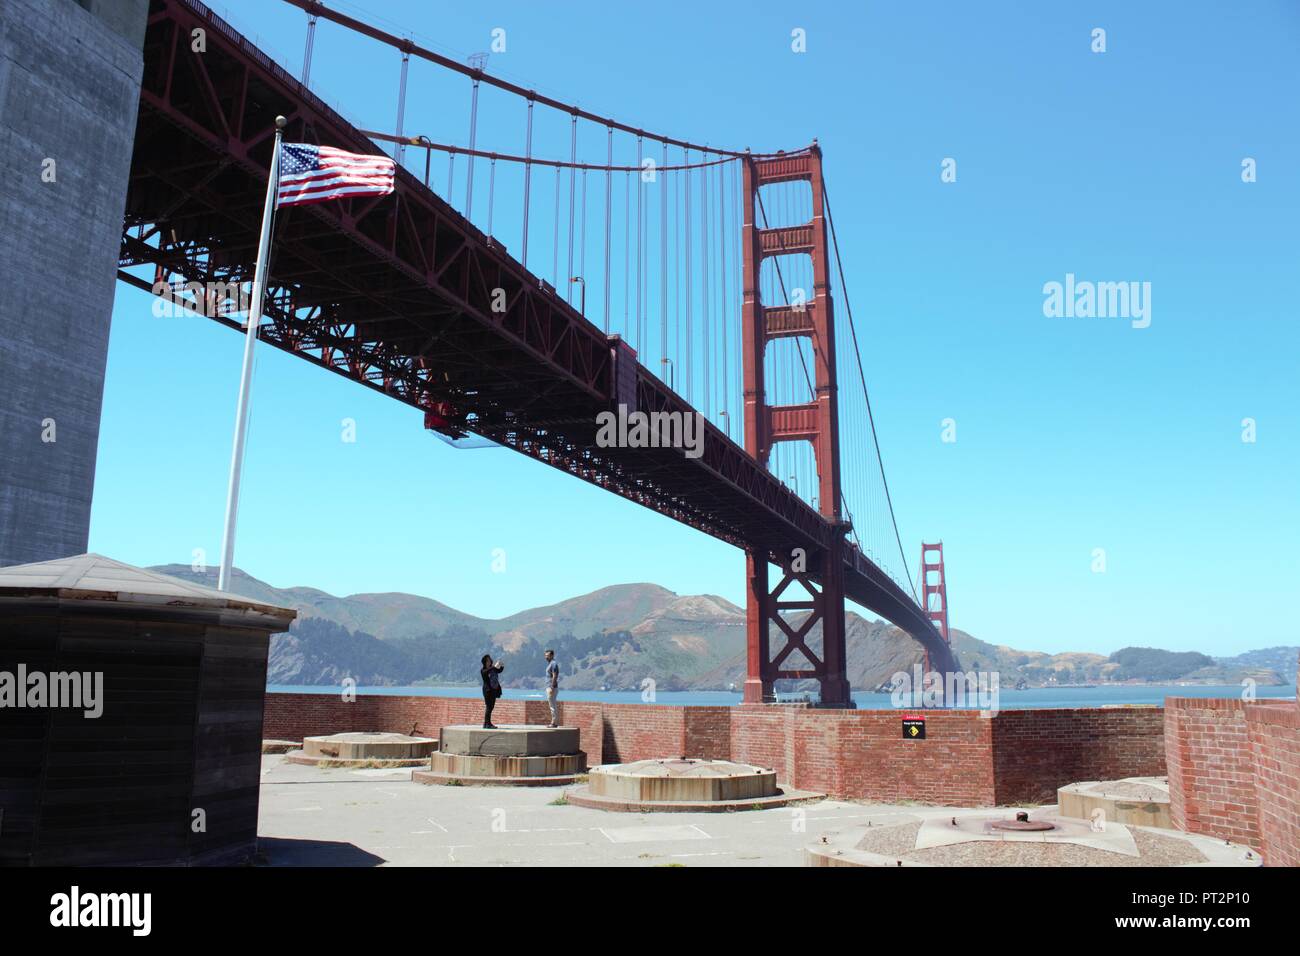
{"left": 741, "top": 140, "right": 853, "bottom": 708}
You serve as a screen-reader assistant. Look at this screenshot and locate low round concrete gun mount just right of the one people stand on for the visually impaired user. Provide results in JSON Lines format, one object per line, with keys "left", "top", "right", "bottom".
{"left": 566, "top": 757, "right": 823, "bottom": 813}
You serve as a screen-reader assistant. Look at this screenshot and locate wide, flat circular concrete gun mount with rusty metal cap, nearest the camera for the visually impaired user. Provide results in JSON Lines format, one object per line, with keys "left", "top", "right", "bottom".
{"left": 805, "top": 809, "right": 1262, "bottom": 868}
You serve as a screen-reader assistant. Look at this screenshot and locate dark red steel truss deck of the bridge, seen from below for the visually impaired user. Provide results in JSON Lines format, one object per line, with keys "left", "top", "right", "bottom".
{"left": 120, "top": 0, "right": 948, "bottom": 676}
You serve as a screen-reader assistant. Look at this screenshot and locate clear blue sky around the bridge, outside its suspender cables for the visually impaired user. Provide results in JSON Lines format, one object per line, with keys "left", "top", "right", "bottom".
{"left": 91, "top": 0, "right": 1300, "bottom": 654}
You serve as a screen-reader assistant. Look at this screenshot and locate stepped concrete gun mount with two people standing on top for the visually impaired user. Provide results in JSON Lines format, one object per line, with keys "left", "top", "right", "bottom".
{"left": 411, "top": 724, "right": 586, "bottom": 787}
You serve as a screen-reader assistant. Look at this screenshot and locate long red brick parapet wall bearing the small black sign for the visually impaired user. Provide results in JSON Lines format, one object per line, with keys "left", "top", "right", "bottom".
{"left": 264, "top": 693, "right": 1165, "bottom": 806}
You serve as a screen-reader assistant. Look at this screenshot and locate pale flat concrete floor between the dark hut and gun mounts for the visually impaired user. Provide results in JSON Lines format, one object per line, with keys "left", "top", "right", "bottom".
{"left": 259, "top": 756, "right": 915, "bottom": 866}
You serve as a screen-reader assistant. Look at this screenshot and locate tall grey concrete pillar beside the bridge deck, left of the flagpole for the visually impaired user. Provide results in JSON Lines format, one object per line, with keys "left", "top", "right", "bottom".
{"left": 0, "top": 0, "right": 148, "bottom": 566}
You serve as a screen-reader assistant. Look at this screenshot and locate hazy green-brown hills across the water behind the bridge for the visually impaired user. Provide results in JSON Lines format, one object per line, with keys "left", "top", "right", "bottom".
{"left": 152, "top": 564, "right": 1300, "bottom": 691}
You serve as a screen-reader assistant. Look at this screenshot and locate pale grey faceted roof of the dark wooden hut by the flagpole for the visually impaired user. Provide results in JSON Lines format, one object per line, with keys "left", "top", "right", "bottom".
{"left": 0, "top": 553, "right": 298, "bottom": 631}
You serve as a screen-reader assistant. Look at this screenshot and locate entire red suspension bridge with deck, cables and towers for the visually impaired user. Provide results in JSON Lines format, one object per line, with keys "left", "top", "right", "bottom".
{"left": 118, "top": 0, "right": 956, "bottom": 706}
